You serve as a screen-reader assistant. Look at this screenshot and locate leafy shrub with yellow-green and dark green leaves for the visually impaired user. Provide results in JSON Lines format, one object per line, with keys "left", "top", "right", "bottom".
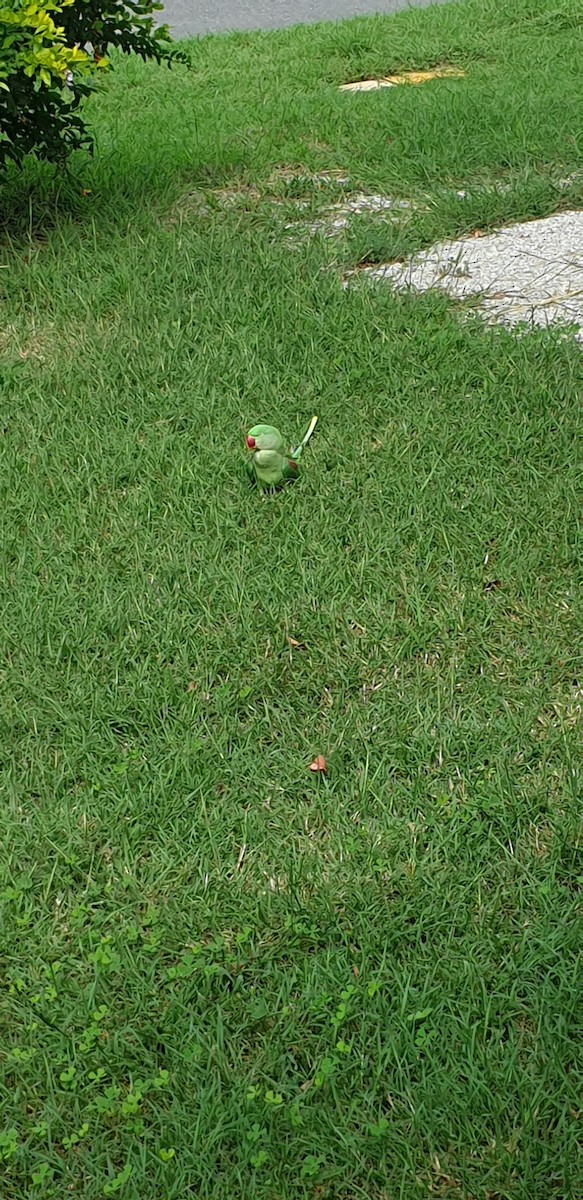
{"left": 0, "top": 0, "right": 174, "bottom": 168}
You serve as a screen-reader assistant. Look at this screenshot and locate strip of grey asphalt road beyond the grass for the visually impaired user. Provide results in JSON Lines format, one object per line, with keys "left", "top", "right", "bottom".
{"left": 160, "top": 0, "right": 451, "bottom": 37}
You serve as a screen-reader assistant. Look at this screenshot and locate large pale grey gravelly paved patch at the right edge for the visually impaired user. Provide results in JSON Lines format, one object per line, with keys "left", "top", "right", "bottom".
{"left": 357, "top": 211, "right": 583, "bottom": 341}
